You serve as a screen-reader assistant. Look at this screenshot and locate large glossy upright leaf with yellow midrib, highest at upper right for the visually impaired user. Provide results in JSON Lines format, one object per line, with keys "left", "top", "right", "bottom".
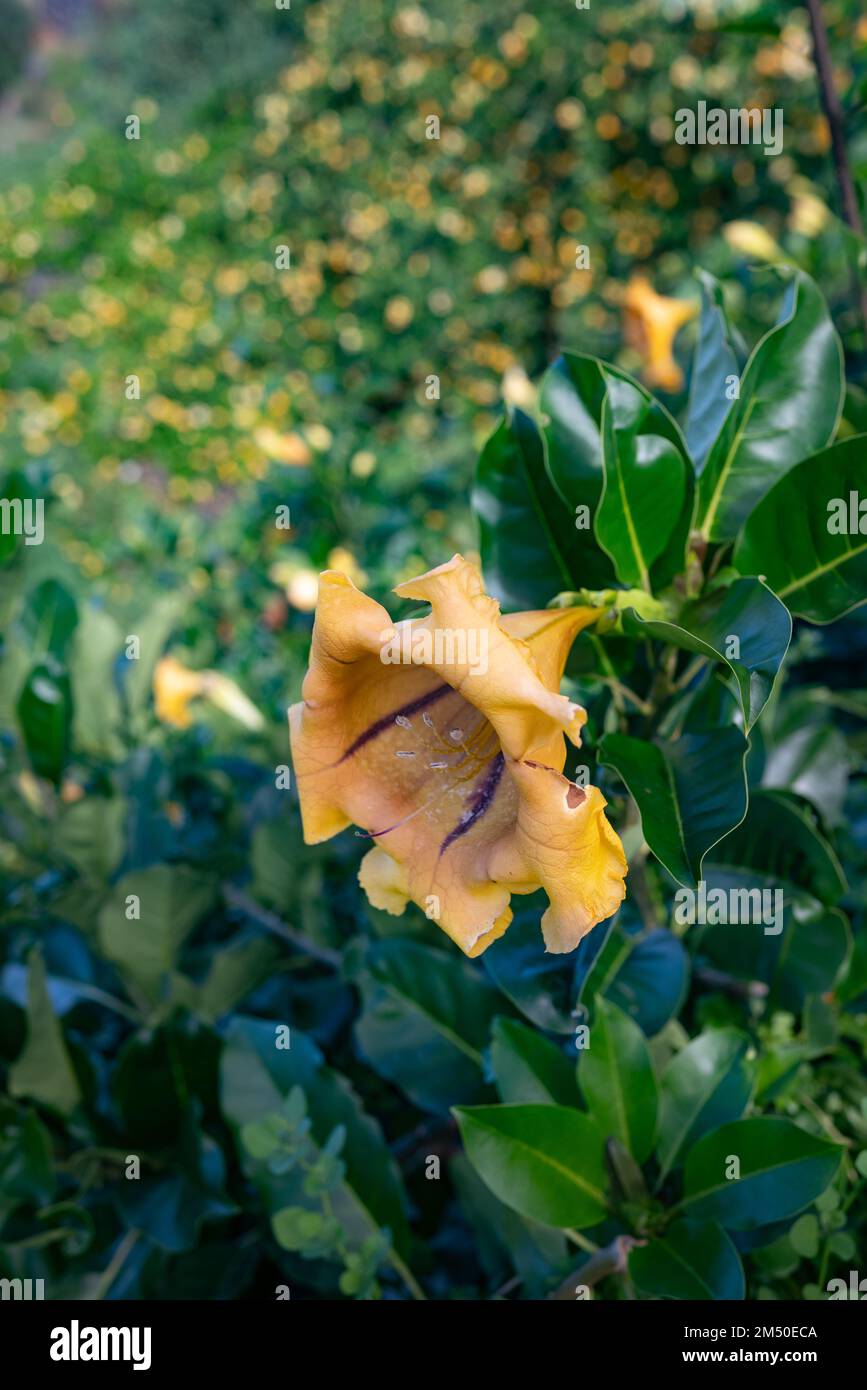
{"left": 695, "top": 271, "right": 843, "bottom": 539}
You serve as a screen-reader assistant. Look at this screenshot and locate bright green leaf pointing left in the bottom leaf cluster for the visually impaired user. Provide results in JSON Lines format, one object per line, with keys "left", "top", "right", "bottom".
{"left": 454, "top": 1105, "right": 606, "bottom": 1229}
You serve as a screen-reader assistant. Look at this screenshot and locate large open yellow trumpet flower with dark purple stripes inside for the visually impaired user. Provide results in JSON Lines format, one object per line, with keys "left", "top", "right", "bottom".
{"left": 289, "top": 555, "right": 627, "bottom": 956}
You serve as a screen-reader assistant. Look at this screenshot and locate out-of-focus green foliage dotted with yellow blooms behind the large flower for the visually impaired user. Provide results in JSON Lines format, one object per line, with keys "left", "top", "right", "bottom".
{"left": 0, "top": 0, "right": 867, "bottom": 1297}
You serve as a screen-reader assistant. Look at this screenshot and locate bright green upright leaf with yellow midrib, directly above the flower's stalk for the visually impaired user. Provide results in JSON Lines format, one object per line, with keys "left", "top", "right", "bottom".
{"left": 595, "top": 373, "right": 686, "bottom": 591}
